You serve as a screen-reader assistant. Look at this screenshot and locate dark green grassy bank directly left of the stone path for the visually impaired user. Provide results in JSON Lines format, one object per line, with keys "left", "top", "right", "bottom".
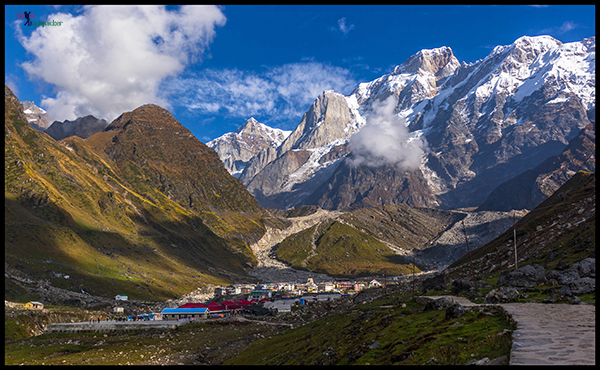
{"left": 225, "top": 296, "right": 511, "bottom": 365}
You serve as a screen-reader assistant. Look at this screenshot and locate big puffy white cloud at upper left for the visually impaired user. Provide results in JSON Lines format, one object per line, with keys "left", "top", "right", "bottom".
{"left": 17, "top": 6, "right": 226, "bottom": 121}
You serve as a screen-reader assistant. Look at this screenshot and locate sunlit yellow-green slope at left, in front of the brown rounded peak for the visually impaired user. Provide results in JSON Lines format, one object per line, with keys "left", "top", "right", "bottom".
{"left": 5, "top": 88, "right": 260, "bottom": 300}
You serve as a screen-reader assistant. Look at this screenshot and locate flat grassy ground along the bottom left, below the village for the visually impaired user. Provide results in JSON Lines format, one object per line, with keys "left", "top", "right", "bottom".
{"left": 4, "top": 322, "right": 281, "bottom": 365}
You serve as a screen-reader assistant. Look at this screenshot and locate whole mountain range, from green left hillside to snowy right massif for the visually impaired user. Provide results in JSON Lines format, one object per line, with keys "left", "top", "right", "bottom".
{"left": 5, "top": 37, "right": 595, "bottom": 304}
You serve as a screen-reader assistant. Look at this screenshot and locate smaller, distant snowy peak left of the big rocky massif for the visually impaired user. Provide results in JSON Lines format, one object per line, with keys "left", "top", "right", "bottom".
{"left": 206, "top": 118, "right": 291, "bottom": 177}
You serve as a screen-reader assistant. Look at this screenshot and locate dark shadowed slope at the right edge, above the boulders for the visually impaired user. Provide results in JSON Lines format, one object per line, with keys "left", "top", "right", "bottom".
{"left": 448, "top": 171, "right": 596, "bottom": 278}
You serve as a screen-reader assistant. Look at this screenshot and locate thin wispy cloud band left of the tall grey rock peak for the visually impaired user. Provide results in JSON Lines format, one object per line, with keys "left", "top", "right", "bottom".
{"left": 162, "top": 62, "right": 356, "bottom": 128}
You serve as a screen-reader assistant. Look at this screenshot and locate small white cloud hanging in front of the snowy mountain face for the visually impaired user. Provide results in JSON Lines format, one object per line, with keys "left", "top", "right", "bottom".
{"left": 349, "top": 95, "right": 427, "bottom": 170}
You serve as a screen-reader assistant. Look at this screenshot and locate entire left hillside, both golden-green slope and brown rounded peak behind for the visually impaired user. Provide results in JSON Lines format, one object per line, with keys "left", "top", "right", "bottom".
{"left": 5, "top": 86, "right": 267, "bottom": 300}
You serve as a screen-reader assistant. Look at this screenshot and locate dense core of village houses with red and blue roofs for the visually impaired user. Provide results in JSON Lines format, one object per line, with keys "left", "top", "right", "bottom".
{"left": 161, "top": 278, "right": 381, "bottom": 320}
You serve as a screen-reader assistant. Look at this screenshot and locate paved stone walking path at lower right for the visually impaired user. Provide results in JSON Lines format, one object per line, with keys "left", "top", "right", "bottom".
{"left": 423, "top": 296, "right": 596, "bottom": 365}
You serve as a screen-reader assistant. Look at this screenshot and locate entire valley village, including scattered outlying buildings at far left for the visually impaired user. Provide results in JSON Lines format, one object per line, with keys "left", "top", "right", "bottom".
{"left": 22, "top": 276, "right": 418, "bottom": 332}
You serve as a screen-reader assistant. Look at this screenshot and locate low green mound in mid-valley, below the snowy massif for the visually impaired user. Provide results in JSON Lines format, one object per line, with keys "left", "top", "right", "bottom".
{"left": 275, "top": 204, "right": 462, "bottom": 277}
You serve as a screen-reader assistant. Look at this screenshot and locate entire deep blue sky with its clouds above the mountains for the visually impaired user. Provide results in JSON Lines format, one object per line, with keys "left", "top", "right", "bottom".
{"left": 4, "top": 5, "right": 596, "bottom": 142}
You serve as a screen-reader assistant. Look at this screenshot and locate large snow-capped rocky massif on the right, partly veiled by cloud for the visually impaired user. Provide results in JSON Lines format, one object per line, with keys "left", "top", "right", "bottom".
{"left": 213, "top": 36, "right": 596, "bottom": 209}
